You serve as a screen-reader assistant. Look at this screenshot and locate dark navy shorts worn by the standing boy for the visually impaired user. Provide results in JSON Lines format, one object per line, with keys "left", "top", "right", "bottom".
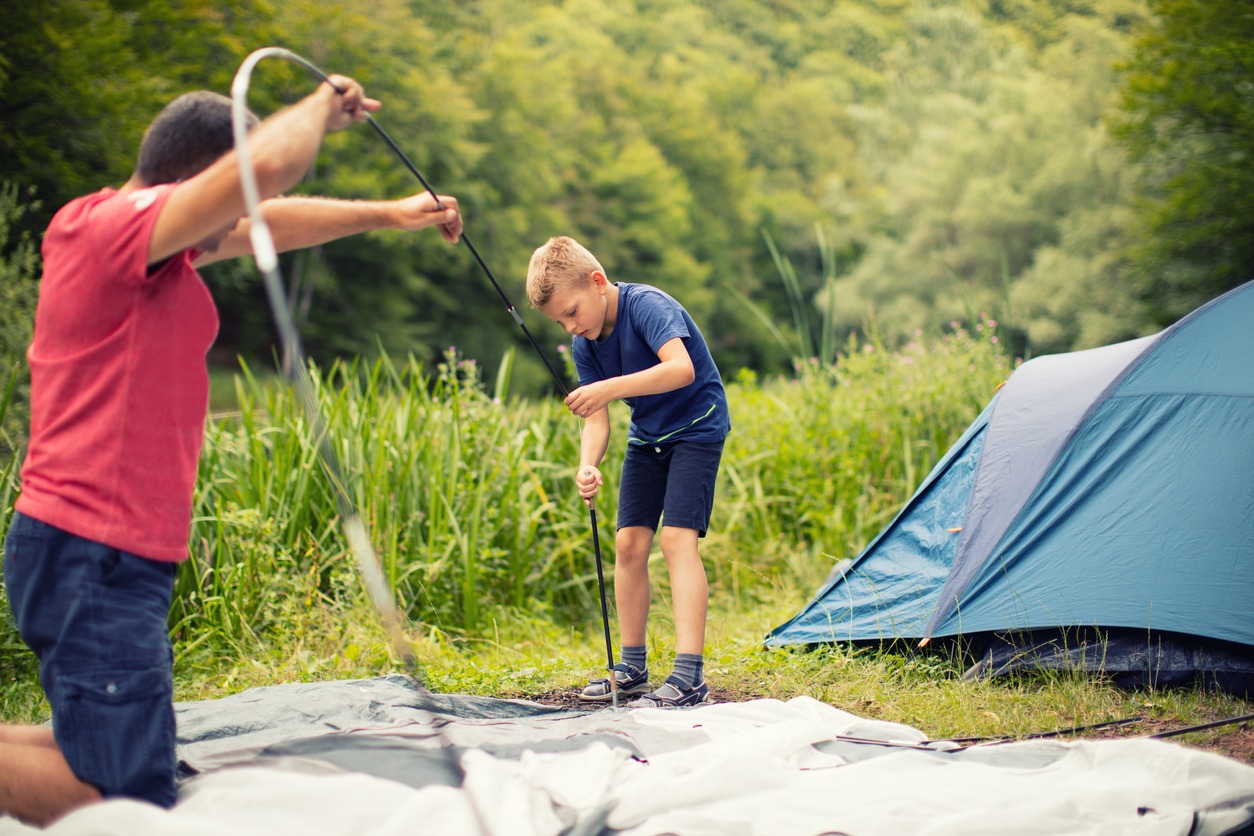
{"left": 618, "top": 441, "right": 722, "bottom": 536}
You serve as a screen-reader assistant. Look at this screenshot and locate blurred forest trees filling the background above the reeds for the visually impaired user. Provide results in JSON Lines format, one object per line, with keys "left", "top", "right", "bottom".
{"left": 0, "top": 0, "right": 1254, "bottom": 391}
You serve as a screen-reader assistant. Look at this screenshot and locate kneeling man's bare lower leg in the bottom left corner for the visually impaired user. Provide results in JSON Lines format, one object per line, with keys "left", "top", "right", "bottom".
{"left": 0, "top": 726, "right": 100, "bottom": 826}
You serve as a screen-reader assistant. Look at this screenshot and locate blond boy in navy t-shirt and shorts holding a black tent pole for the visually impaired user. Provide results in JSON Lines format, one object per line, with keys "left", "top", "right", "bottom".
{"left": 527, "top": 237, "right": 731, "bottom": 707}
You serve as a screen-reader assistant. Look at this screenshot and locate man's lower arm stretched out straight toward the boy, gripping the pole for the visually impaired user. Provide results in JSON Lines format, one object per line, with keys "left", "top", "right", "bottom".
{"left": 196, "top": 192, "right": 461, "bottom": 267}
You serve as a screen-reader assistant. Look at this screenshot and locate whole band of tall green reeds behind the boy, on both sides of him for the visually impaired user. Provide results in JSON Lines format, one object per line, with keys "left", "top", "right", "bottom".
{"left": 172, "top": 322, "right": 1009, "bottom": 638}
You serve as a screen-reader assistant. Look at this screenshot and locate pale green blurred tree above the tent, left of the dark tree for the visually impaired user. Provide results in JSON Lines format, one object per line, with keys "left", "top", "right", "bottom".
{"left": 835, "top": 8, "right": 1147, "bottom": 351}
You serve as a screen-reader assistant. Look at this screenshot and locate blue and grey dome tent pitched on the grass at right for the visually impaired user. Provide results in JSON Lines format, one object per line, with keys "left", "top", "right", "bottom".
{"left": 766, "top": 282, "right": 1254, "bottom": 694}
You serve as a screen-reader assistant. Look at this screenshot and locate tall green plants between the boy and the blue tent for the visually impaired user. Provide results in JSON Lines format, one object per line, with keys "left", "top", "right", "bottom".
{"left": 712, "top": 322, "right": 1011, "bottom": 599}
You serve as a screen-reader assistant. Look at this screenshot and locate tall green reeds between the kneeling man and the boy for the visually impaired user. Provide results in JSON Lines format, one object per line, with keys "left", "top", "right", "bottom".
{"left": 176, "top": 348, "right": 611, "bottom": 632}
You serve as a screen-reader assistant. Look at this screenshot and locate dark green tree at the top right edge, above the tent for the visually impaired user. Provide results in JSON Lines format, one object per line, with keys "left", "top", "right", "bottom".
{"left": 1116, "top": 0, "right": 1254, "bottom": 325}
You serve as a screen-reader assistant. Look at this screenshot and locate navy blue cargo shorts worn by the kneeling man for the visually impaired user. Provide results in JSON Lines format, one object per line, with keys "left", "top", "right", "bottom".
{"left": 4, "top": 514, "right": 177, "bottom": 807}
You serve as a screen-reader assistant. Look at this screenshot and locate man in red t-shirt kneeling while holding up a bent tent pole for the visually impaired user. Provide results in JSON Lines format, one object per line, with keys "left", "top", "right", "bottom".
{"left": 0, "top": 76, "right": 461, "bottom": 825}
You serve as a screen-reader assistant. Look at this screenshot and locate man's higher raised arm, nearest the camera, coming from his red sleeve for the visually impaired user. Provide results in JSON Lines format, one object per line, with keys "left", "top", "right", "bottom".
{"left": 148, "top": 75, "right": 379, "bottom": 264}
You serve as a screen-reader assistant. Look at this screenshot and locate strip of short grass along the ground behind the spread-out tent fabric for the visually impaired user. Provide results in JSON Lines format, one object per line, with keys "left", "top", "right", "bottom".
{"left": 161, "top": 590, "right": 1251, "bottom": 761}
